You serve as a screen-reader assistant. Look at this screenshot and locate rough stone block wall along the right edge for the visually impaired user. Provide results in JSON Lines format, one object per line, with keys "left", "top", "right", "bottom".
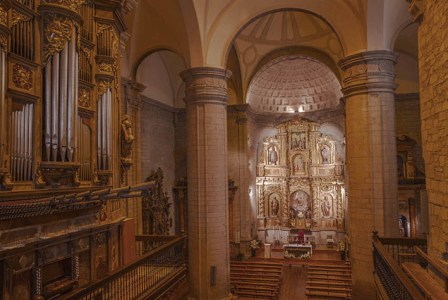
{"left": 418, "top": 0, "right": 448, "bottom": 258}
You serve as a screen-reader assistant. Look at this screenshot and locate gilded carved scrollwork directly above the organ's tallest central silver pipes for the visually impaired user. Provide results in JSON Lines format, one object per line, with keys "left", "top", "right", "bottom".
{"left": 43, "top": 14, "right": 74, "bottom": 63}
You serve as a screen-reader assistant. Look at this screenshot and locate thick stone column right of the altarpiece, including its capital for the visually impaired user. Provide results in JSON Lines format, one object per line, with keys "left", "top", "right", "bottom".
{"left": 340, "top": 50, "right": 398, "bottom": 299}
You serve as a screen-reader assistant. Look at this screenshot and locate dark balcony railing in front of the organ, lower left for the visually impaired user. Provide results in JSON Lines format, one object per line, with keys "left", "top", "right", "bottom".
{"left": 61, "top": 236, "right": 187, "bottom": 300}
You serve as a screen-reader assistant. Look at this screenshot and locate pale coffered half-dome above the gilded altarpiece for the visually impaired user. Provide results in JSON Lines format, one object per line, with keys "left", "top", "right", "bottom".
{"left": 247, "top": 58, "right": 342, "bottom": 113}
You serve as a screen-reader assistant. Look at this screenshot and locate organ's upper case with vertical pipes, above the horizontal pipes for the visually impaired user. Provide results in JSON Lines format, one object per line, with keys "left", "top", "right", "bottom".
{"left": 0, "top": 0, "right": 125, "bottom": 190}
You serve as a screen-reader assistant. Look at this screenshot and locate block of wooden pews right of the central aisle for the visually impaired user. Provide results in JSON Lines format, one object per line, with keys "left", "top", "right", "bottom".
{"left": 305, "top": 263, "right": 352, "bottom": 299}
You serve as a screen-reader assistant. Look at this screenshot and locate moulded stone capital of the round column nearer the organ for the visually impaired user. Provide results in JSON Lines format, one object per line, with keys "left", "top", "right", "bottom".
{"left": 180, "top": 67, "right": 232, "bottom": 105}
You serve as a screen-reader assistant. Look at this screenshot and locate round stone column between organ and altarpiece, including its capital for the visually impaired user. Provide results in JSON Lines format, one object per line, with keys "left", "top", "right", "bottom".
{"left": 181, "top": 67, "right": 231, "bottom": 300}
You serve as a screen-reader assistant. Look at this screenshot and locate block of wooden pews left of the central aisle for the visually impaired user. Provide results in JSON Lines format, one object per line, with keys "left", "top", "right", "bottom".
{"left": 230, "top": 261, "right": 283, "bottom": 299}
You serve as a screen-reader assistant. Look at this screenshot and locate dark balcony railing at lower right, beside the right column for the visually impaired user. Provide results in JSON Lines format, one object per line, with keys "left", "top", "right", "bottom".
{"left": 373, "top": 235, "right": 425, "bottom": 300}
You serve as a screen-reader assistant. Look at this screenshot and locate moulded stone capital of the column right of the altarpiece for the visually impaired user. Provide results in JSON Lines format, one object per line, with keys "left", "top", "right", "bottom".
{"left": 339, "top": 50, "right": 398, "bottom": 97}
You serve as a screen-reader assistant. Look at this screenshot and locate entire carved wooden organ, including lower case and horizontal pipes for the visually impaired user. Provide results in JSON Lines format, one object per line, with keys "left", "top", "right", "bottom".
{"left": 0, "top": 0, "right": 145, "bottom": 300}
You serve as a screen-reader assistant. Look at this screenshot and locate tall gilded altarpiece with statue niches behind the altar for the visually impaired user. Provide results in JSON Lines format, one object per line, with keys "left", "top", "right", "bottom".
{"left": 256, "top": 118, "right": 346, "bottom": 244}
